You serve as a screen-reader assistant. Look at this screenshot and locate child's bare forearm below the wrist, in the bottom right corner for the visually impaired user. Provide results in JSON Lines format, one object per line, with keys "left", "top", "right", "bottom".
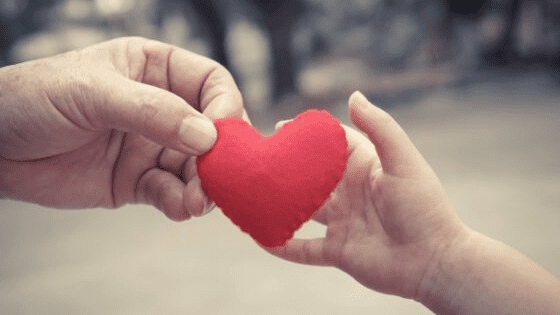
{"left": 417, "top": 232, "right": 560, "bottom": 315}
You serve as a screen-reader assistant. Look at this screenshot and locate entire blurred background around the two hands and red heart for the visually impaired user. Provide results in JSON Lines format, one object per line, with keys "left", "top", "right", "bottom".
{"left": 0, "top": 0, "right": 560, "bottom": 314}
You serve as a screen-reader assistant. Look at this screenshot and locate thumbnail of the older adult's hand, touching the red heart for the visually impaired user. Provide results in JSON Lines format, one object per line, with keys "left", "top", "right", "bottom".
{"left": 179, "top": 116, "right": 218, "bottom": 154}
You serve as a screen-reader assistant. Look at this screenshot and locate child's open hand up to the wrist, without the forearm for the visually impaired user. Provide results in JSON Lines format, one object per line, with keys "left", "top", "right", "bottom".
{"left": 267, "top": 93, "right": 467, "bottom": 298}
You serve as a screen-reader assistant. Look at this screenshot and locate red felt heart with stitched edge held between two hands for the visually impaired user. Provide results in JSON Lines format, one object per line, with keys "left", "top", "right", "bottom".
{"left": 197, "top": 110, "right": 348, "bottom": 247}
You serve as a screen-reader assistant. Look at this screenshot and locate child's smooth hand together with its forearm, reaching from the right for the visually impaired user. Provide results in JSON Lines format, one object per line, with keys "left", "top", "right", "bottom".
{"left": 266, "top": 92, "right": 560, "bottom": 314}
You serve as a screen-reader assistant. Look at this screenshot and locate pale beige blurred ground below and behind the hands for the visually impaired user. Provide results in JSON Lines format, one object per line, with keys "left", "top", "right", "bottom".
{"left": 0, "top": 75, "right": 560, "bottom": 315}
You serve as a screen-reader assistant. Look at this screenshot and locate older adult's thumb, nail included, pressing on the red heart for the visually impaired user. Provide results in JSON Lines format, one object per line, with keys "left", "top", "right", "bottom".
{"left": 96, "top": 78, "right": 217, "bottom": 155}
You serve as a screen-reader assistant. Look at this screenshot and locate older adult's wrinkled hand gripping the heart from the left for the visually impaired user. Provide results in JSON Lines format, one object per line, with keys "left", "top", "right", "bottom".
{"left": 0, "top": 38, "right": 247, "bottom": 220}
